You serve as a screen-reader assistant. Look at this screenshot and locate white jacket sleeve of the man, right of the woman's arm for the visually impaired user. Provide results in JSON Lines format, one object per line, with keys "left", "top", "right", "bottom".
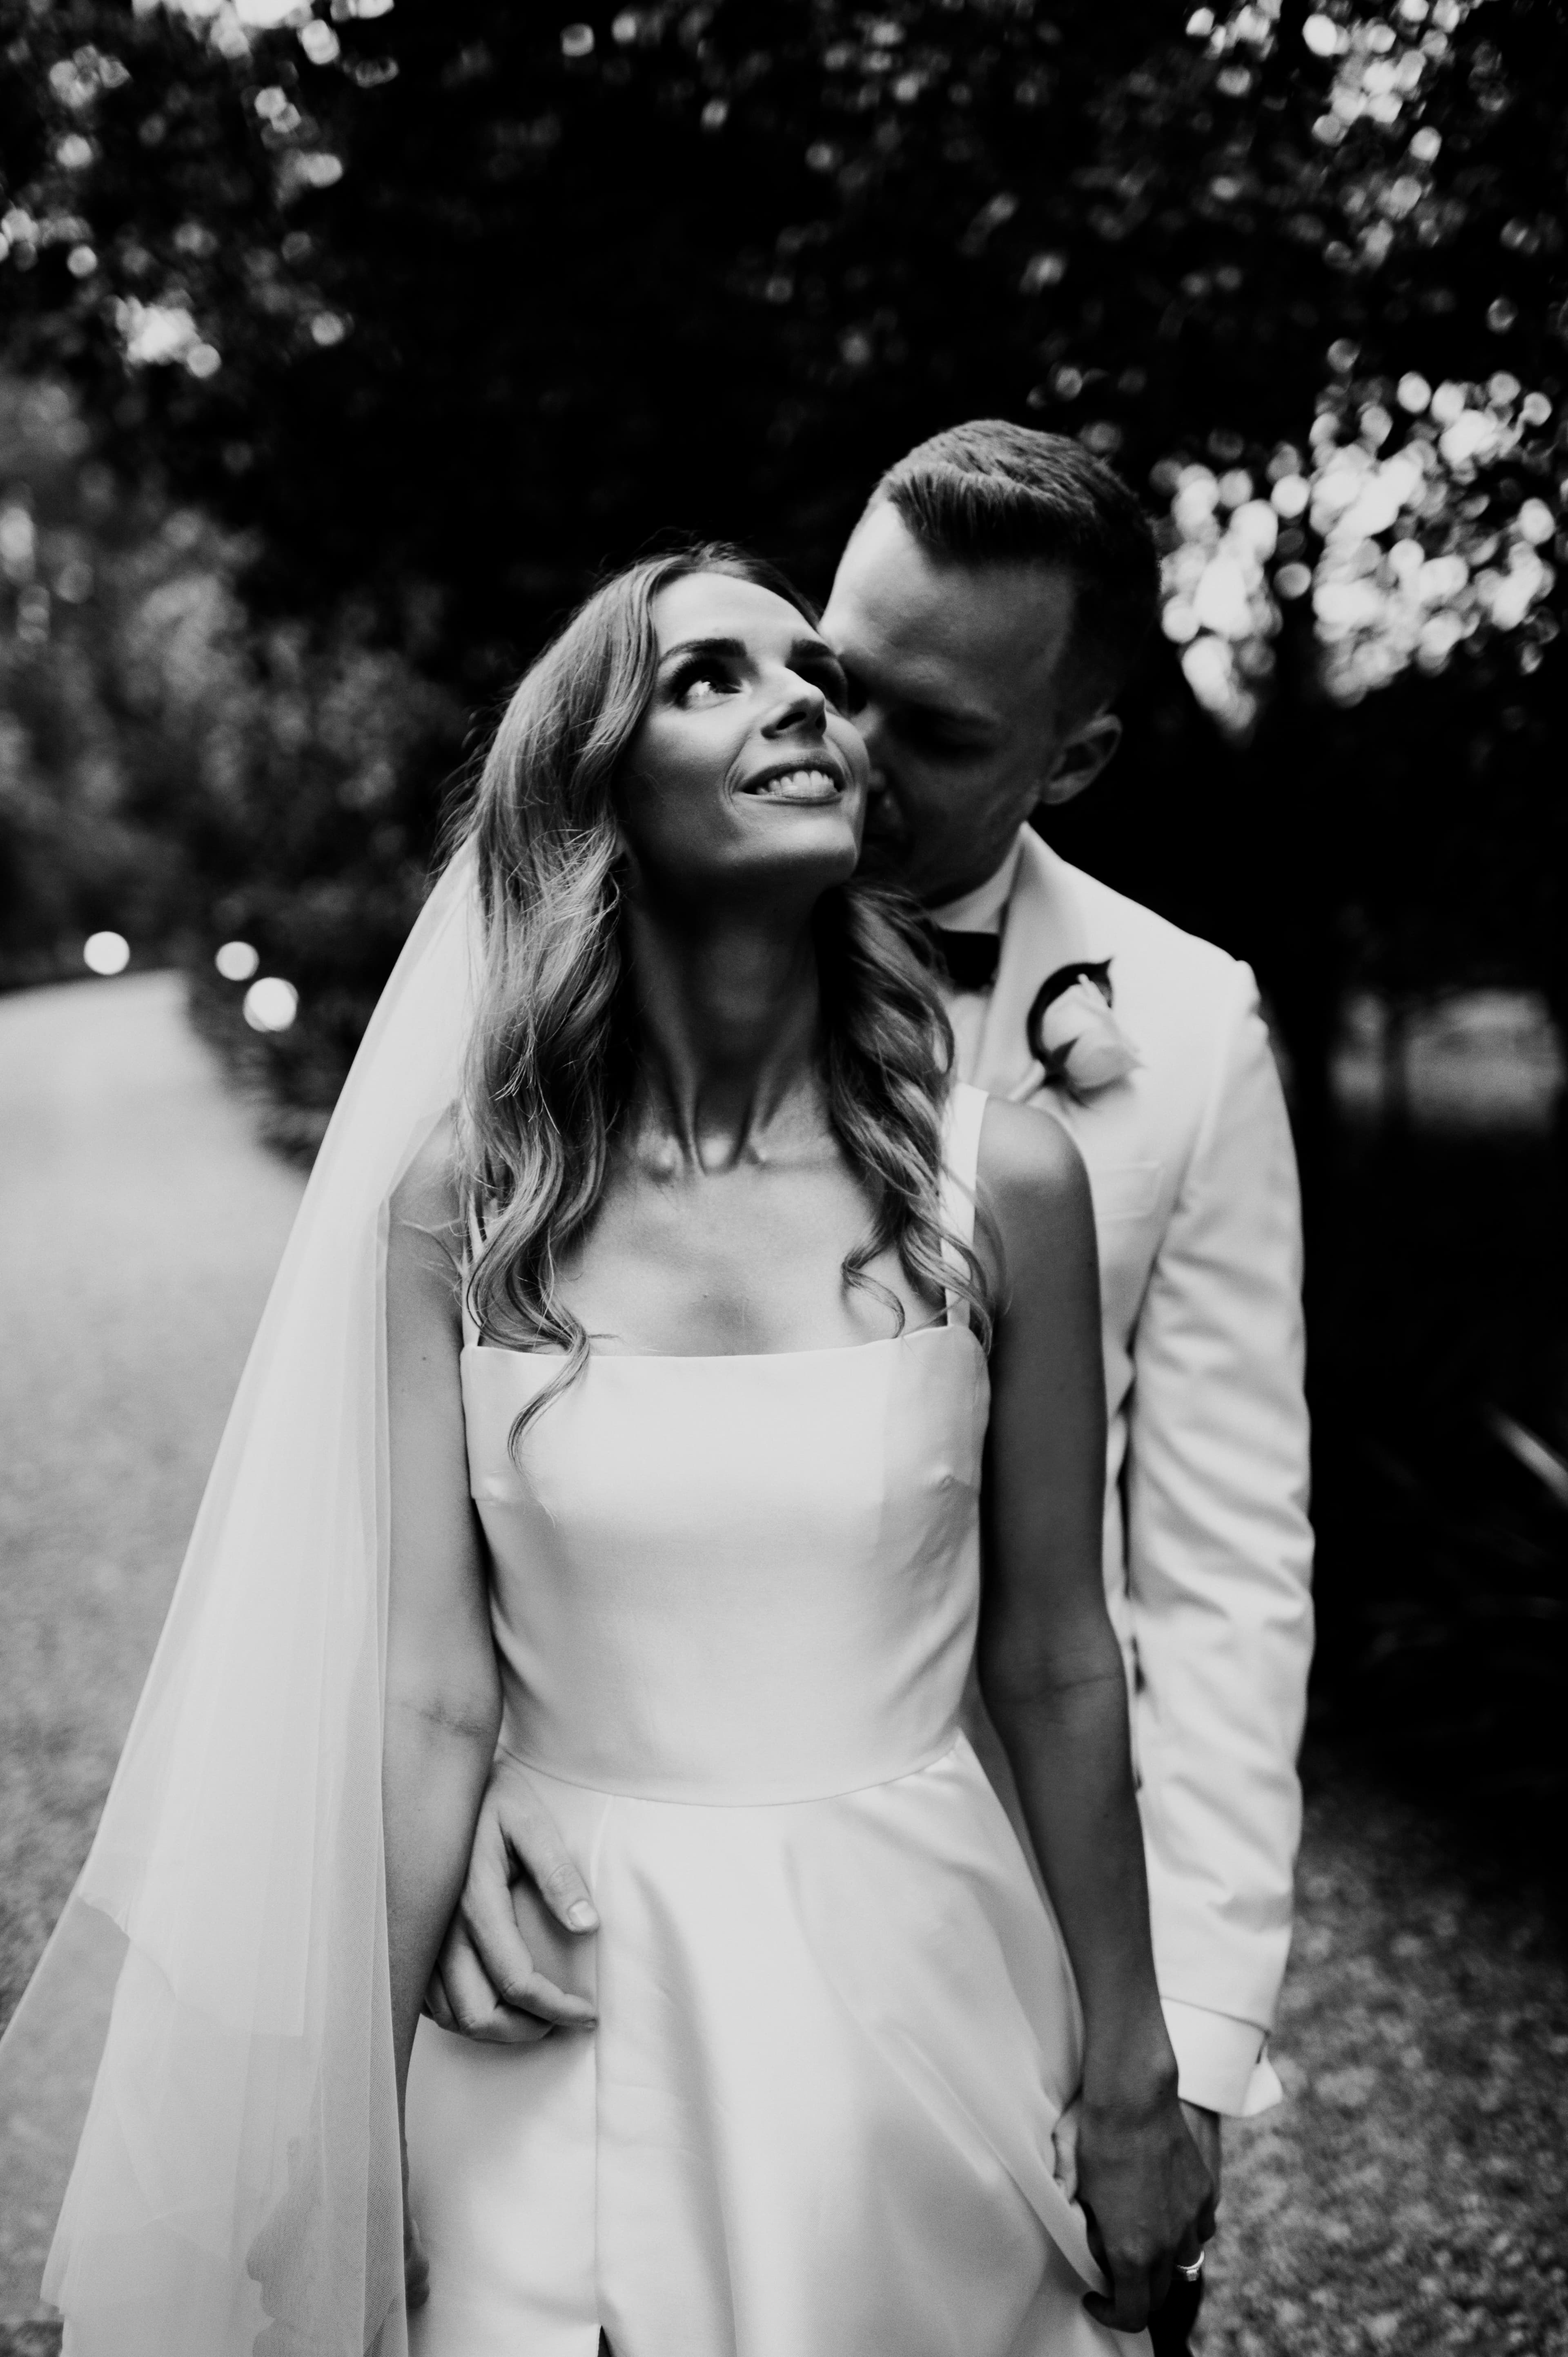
{"left": 1127, "top": 966, "right": 1311, "bottom": 2114}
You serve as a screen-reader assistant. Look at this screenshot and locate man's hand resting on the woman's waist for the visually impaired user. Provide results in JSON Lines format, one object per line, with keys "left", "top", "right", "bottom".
{"left": 424, "top": 1754, "right": 599, "bottom": 2046}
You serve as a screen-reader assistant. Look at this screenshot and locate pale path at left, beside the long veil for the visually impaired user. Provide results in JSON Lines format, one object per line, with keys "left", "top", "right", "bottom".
{"left": 0, "top": 973, "right": 299, "bottom": 2319}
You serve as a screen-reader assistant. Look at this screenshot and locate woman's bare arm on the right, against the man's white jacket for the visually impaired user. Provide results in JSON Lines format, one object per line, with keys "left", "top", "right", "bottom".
{"left": 978, "top": 1101, "right": 1207, "bottom": 2331}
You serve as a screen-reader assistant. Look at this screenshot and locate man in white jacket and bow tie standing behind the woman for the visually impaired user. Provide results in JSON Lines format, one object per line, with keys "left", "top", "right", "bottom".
{"left": 432, "top": 433, "right": 1311, "bottom": 2350}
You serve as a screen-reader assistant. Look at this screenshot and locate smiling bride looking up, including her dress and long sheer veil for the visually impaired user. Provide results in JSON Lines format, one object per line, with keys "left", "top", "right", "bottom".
{"left": 6, "top": 549, "right": 1207, "bottom": 2357}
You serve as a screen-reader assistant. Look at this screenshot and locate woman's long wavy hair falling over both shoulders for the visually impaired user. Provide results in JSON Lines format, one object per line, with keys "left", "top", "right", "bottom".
{"left": 457, "top": 544, "right": 993, "bottom": 1447}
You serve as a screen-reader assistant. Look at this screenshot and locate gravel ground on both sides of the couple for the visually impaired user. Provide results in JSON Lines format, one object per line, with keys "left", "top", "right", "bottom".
{"left": 0, "top": 976, "right": 1568, "bottom": 2357}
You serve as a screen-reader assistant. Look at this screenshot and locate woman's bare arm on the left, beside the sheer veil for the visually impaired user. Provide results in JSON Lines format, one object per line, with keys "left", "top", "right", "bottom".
{"left": 382, "top": 1134, "right": 500, "bottom": 2114}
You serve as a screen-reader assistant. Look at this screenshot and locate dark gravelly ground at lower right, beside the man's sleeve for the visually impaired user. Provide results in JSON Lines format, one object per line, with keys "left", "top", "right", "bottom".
{"left": 1198, "top": 1758, "right": 1568, "bottom": 2357}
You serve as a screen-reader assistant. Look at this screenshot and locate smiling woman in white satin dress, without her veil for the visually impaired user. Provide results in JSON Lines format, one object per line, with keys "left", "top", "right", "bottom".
{"left": 384, "top": 542, "right": 1203, "bottom": 2357}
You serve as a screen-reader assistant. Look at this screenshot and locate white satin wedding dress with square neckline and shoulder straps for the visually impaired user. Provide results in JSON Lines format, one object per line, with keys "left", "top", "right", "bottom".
{"left": 408, "top": 1089, "right": 1146, "bottom": 2357}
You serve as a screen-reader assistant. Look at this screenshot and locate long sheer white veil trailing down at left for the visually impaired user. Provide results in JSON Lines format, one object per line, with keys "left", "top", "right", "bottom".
{"left": 0, "top": 851, "right": 481, "bottom": 2357}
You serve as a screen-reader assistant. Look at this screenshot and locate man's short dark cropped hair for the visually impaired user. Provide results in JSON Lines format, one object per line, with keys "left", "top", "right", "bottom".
{"left": 868, "top": 417, "right": 1160, "bottom": 716}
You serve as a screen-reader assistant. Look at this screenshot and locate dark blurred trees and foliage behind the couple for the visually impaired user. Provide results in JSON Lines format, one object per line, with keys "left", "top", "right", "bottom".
{"left": 0, "top": 0, "right": 1568, "bottom": 1855}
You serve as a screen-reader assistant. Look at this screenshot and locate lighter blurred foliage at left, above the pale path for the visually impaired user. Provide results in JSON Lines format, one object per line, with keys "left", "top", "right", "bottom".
{"left": 0, "top": 379, "right": 462, "bottom": 1103}
